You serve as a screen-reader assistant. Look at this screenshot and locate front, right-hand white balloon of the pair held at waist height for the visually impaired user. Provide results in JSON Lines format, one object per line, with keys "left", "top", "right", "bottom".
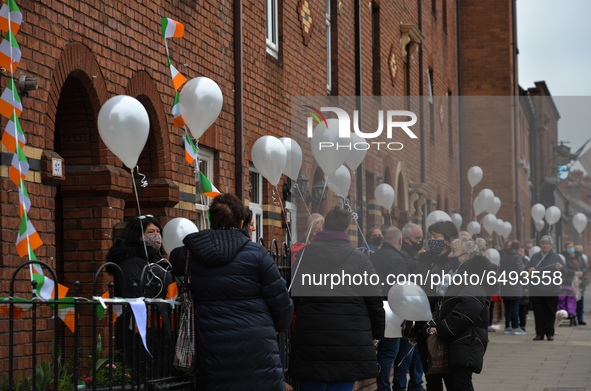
{"left": 388, "top": 282, "right": 433, "bottom": 321}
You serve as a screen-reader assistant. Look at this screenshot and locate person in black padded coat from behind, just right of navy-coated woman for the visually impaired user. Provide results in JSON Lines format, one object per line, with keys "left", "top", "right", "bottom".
{"left": 289, "top": 208, "right": 385, "bottom": 391}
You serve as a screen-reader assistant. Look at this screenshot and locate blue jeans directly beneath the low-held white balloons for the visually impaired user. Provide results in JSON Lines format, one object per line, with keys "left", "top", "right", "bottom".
{"left": 392, "top": 338, "right": 423, "bottom": 391}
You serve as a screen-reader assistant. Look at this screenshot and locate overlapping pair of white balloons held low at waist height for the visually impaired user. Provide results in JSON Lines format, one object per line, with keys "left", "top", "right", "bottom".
{"left": 384, "top": 282, "right": 433, "bottom": 338}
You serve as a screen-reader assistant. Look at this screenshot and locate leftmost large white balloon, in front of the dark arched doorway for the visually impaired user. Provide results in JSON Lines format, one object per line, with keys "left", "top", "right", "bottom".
{"left": 97, "top": 95, "right": 150, "bottom": 170}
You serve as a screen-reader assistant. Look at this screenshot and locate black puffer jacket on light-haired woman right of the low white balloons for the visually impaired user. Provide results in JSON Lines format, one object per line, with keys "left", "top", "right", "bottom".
{"left": 433, "top": 256, "right": 497, "bottom": 373}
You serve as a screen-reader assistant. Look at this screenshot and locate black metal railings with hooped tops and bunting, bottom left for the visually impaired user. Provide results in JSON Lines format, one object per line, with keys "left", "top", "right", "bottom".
{"left": 0, "top": 240, "right": 293, "bottom": 391}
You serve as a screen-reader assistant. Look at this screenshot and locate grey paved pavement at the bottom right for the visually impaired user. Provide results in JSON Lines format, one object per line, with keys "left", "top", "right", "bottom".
{"left": 473, "top": 298, "right": 591, "bottom": 391}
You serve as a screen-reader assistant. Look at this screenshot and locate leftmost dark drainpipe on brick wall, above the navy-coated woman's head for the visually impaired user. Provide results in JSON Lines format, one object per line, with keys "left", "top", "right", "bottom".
{"left": 234, "top": 0, "right": 244, "bottom": 201}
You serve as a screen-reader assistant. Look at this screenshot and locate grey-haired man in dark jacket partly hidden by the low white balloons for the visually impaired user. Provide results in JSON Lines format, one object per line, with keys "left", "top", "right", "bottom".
{"left": 370, "top": 227, "right": 407, "bottom": 391}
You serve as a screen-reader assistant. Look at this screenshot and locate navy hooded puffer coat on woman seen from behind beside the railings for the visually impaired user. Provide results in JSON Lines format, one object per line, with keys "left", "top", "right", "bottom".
{"left": 170, "top": 229, "right": 293, "bottom": 391}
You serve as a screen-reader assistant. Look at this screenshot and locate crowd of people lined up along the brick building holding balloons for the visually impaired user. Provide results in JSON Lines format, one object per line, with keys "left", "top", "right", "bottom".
{"left": 107, "top": 194, "right": 588, "bottom": 391}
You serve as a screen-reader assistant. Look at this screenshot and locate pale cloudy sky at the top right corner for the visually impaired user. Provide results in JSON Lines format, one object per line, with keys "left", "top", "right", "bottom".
{"left": 517, "top": 0, "right": 591, "bottom": 174}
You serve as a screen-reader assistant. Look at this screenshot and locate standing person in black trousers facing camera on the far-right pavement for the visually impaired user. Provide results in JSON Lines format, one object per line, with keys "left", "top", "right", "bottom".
{"left": 527, "top": 235, "right": 564, "bottom": 341}
